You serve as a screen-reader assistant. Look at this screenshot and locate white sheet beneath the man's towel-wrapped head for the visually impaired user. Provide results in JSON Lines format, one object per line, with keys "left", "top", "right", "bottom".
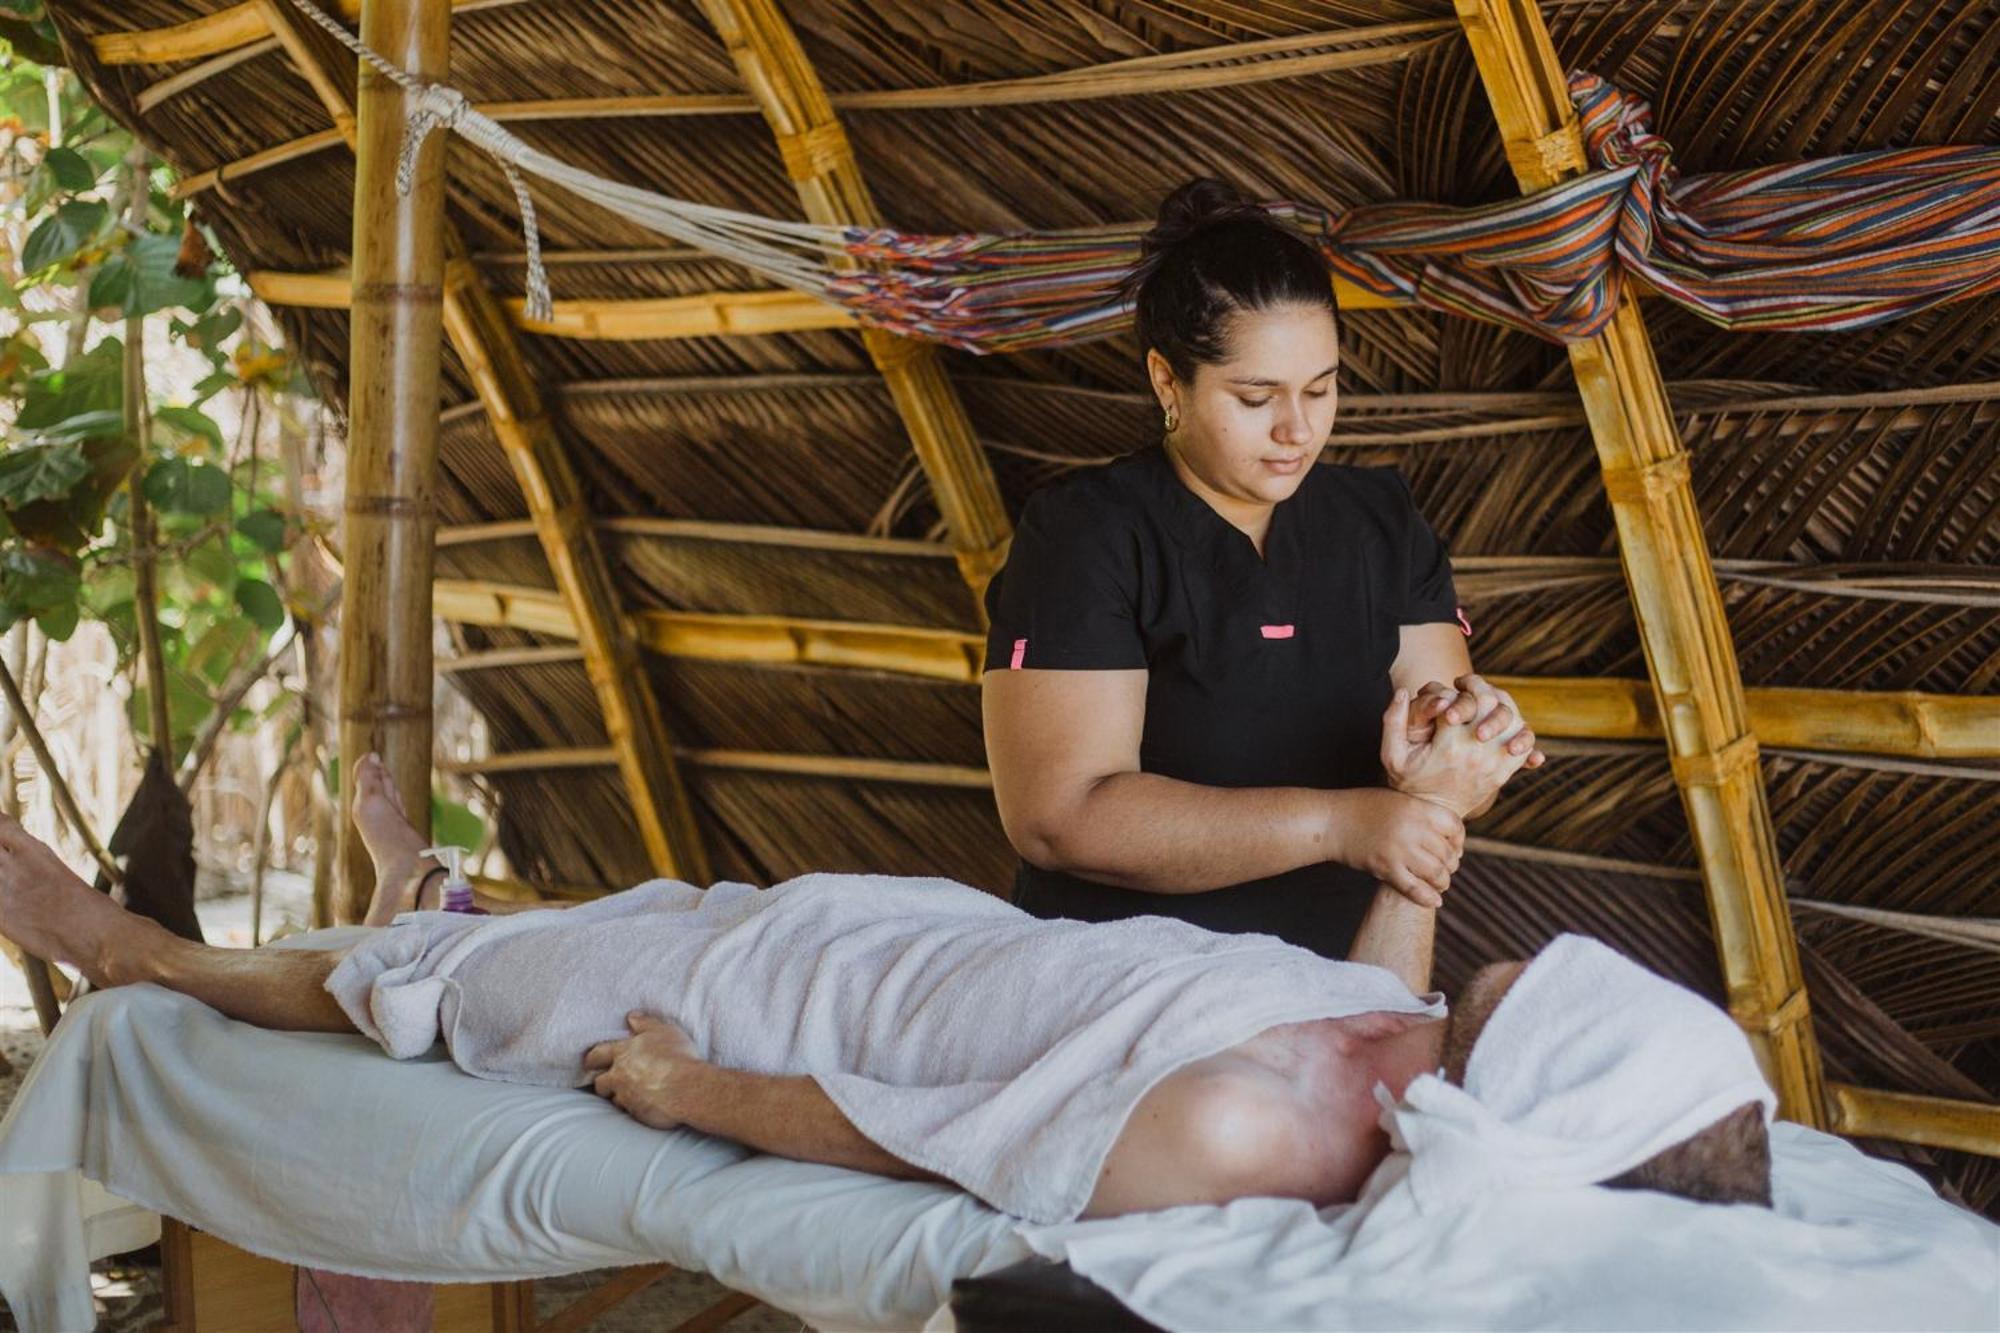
{"left": 1028, "top": 1123, "right": 2000, "bottom": 1333}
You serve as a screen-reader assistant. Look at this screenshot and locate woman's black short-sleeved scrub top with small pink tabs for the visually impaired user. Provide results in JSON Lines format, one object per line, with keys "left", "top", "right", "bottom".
{"left": 986, "top": 446, "right": 1462, "bottom": 959}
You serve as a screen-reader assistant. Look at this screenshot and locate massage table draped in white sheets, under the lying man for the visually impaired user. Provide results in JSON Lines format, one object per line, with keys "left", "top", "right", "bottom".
{"left": 0, "top": 935, "right": 2000, "bottom": 1333}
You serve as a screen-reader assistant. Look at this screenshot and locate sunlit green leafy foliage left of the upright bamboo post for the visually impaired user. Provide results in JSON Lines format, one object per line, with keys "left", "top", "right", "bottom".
{"left": 0, "top": 59, "right": 306, "bottom": 768}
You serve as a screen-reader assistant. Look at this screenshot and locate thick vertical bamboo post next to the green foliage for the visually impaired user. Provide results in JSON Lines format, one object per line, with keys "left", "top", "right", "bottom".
{"left": 334, "top": 0, "right": 452, "bottom": 921}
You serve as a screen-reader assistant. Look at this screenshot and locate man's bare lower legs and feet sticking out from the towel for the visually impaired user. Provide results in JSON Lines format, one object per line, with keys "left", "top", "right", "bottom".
{"left": 0, "top": 755, "right": 442, "bottom": 1033}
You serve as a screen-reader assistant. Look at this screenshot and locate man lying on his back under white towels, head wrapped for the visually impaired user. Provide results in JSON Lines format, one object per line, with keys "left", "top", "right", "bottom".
{"left": 0, "top": 725, "right": 1772, "bottom": 1221}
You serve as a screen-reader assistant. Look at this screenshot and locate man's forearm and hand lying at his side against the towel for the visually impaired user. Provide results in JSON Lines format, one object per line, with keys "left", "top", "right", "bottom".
{"left": 584, "top": 1013, "right": 942, "bottom": 1181}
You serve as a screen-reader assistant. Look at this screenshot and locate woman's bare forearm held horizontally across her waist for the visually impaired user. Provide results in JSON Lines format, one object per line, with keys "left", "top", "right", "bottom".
{"left": 1022, "top": 773, "right": 1358, "bottom": 893}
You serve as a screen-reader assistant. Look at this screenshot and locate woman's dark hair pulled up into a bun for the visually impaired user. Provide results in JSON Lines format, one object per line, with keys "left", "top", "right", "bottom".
{"left": 1128, "top": 176, "right": 1340, "bottom": 380}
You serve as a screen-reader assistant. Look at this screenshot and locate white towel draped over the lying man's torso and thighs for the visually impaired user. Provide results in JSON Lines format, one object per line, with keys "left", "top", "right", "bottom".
{"left": 328, "top": 875, "right": 1444, "bottom": 1221}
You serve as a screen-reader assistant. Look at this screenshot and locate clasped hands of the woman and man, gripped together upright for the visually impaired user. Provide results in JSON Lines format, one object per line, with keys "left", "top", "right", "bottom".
{"left": 1350, "top": 675, "right": 1546, "bottom": 909}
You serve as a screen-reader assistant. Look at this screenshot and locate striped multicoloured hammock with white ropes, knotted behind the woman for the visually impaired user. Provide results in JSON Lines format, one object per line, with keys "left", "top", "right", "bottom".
{"left": 292, "top": 0, "right": 2000, "bottom": 354}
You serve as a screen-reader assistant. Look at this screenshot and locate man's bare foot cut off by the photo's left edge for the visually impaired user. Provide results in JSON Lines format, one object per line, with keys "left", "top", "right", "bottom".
{"left": 0, "top": 815, "right": 163, "bottom": 987}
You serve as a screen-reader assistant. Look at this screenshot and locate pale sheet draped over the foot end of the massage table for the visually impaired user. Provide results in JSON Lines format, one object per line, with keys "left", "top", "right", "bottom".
{"left": 0, "top": 932, "right": 1030, "bottom": 1333}
